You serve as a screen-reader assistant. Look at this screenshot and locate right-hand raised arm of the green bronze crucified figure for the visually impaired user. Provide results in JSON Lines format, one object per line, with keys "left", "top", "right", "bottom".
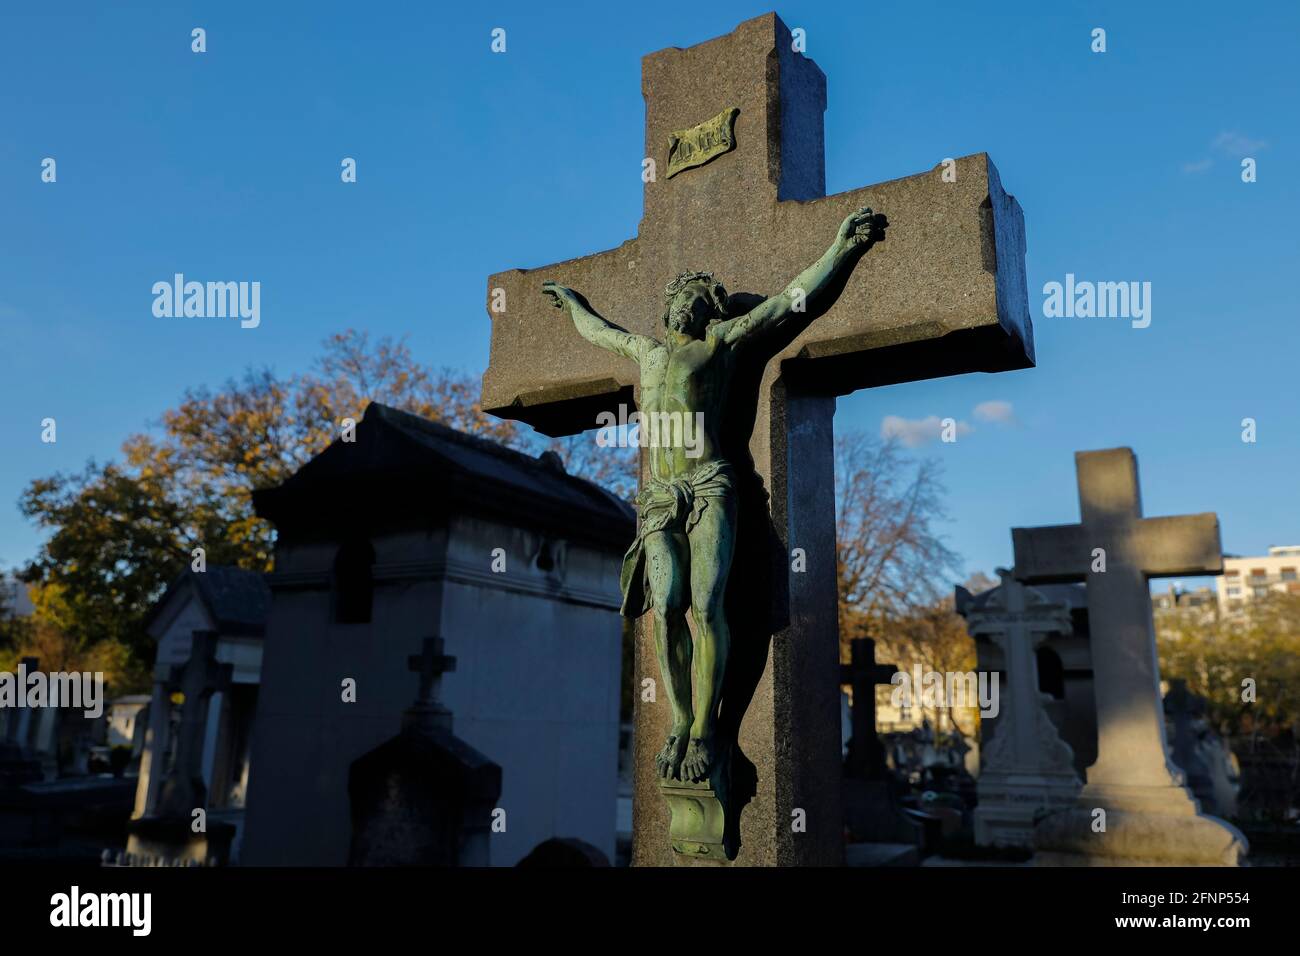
{"left": 710, "top": 206, "right": 888, "bottom": 345}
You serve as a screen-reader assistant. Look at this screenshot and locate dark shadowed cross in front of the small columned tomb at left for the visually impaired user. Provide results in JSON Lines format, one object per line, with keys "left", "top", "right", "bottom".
{"left": 157, "top": 631, "right": 233, "bottom": 817}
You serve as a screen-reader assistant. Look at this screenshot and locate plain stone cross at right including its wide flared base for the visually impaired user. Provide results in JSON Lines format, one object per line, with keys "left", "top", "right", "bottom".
{"left": 1011, "top": 447, "right": 1247, "bottom": 866}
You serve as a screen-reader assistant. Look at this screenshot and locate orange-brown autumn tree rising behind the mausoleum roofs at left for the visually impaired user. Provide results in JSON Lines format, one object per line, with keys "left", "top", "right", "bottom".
{"left": 20, "top": 330, "right": 636, "bottom": 681}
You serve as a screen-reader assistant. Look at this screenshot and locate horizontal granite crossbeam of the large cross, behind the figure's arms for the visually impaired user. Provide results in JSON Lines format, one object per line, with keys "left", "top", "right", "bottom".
{"left": 481, "top": 153, "right": 1034, "bottom": 434}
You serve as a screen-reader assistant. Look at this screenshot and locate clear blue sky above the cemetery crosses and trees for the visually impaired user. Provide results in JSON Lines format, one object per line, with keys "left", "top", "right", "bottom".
{"left": 0, "top": 0, "right": 1300, "bottom": 587}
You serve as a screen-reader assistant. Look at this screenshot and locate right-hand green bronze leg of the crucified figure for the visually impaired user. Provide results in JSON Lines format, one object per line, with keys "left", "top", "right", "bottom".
{"left": 681, "top": 498, "right": 736, "bottom": 780}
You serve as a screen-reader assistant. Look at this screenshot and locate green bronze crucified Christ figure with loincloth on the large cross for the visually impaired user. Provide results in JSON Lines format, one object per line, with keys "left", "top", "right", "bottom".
{"left": 542, "top": 208, "right": 888, "bottom": 783}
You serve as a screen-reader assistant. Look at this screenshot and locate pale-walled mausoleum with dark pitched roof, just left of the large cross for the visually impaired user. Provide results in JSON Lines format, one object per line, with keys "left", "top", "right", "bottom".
{"left": 242, "top": 403, "right": 634, "bottom": 866}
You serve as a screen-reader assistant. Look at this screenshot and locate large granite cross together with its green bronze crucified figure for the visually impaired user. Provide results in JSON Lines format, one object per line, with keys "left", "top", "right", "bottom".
{"left": 482, "top": 14, "right": 1034, "bottom": 865}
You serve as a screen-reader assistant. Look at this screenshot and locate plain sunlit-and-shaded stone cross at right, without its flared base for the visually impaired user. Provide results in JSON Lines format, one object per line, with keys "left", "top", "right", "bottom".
{"left": 1011, "top": 449, "right": 1223, "bottom": 793}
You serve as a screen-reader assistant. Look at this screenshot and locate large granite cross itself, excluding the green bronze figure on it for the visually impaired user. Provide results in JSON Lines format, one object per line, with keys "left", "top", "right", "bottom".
{"left": 481, "top": 14, "right": 1034, "bottom": 865}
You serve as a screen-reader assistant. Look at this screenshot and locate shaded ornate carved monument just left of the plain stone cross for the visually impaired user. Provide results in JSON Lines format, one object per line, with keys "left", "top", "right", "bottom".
{"left": 957, "top": 568, "right": 1082, "bottom": 847}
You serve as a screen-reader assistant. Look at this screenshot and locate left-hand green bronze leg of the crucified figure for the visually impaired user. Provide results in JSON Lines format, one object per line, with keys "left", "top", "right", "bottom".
{"left": 645, "top": 531, "right": 690, "bottom": 779}
